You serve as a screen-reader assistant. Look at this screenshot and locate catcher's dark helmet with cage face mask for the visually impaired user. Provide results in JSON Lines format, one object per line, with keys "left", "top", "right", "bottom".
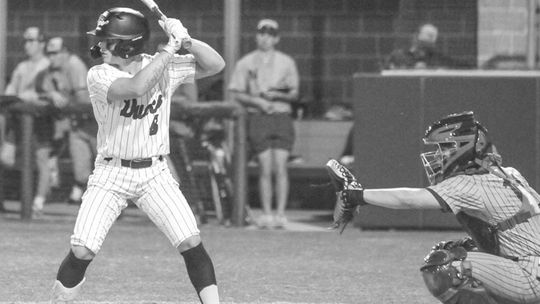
{"left": 420, "top": 112, "right": 494, "bottom": 185}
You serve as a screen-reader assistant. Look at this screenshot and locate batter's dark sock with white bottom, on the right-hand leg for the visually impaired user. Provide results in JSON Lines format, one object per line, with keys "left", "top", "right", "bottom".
{"left": 182, "top": 243, "right": 219, "bottom": 303}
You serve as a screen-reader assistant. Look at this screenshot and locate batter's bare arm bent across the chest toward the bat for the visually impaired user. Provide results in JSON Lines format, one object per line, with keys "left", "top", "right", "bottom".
{"left": 107, "top": 51, "right": 173, "bottom": 100}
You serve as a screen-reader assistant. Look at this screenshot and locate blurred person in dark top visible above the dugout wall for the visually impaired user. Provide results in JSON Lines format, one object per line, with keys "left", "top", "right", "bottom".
{"left": 384, "top": 23, "right": 471, "bottom": 69}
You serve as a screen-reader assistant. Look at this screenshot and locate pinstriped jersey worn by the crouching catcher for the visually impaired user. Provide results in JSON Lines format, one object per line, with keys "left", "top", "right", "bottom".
{"left": 429, "top": 168, "right": 540, "bottom": 257}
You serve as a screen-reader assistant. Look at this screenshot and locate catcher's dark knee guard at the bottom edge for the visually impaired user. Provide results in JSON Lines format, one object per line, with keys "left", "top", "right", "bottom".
{"left": 420, "top": 248, "right": 495, "bottom": 304}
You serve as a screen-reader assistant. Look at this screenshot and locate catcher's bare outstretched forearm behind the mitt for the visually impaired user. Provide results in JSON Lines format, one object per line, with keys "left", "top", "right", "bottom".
{"left": 364, "top": 188, "right": 441, "bottom": 209}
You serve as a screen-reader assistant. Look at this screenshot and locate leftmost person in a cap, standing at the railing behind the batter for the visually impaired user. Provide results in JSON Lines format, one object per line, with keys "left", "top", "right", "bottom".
{"left": 2, "top": 27, "right": 54, "bottom": 217}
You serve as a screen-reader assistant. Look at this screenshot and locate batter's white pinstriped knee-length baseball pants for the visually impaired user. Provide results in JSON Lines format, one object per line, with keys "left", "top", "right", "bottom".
{"left": 71, "top": 156, "right": 200, "bottom": 254}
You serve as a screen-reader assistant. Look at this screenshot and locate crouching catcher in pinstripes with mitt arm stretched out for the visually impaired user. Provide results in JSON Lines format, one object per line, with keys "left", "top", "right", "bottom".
{"left": 327, "top": 112, "right": 540, "bottom": 304}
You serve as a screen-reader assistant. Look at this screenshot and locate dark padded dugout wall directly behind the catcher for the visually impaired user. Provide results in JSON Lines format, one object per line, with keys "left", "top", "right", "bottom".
{"left": 354, "top": 70, "right": 540, "bottom": 228}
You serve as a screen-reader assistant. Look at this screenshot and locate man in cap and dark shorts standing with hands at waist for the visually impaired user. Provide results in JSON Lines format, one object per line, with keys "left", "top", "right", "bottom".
{"left": 228, "top": 19, "right": 299, "bottom": 228}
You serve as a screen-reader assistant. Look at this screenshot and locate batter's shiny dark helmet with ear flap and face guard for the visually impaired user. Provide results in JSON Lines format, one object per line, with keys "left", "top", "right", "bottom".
{"left": 87, "top": 7, "right": 150, "bottom": 58}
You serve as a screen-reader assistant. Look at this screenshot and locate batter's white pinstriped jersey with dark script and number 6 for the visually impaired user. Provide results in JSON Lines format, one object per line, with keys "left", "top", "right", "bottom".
{"left": 87, "top": 54, "right": 195, "bottom": 159}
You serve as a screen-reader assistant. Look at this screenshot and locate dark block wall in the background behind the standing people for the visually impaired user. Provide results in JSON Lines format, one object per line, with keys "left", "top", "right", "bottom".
{"left": 7, "top": 0, "right": 476, "bottom": 115}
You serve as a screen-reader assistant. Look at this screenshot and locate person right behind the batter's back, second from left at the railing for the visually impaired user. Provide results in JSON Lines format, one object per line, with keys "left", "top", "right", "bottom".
{"left": 37, "top": 37, "right": 97, "bottom": 204}
